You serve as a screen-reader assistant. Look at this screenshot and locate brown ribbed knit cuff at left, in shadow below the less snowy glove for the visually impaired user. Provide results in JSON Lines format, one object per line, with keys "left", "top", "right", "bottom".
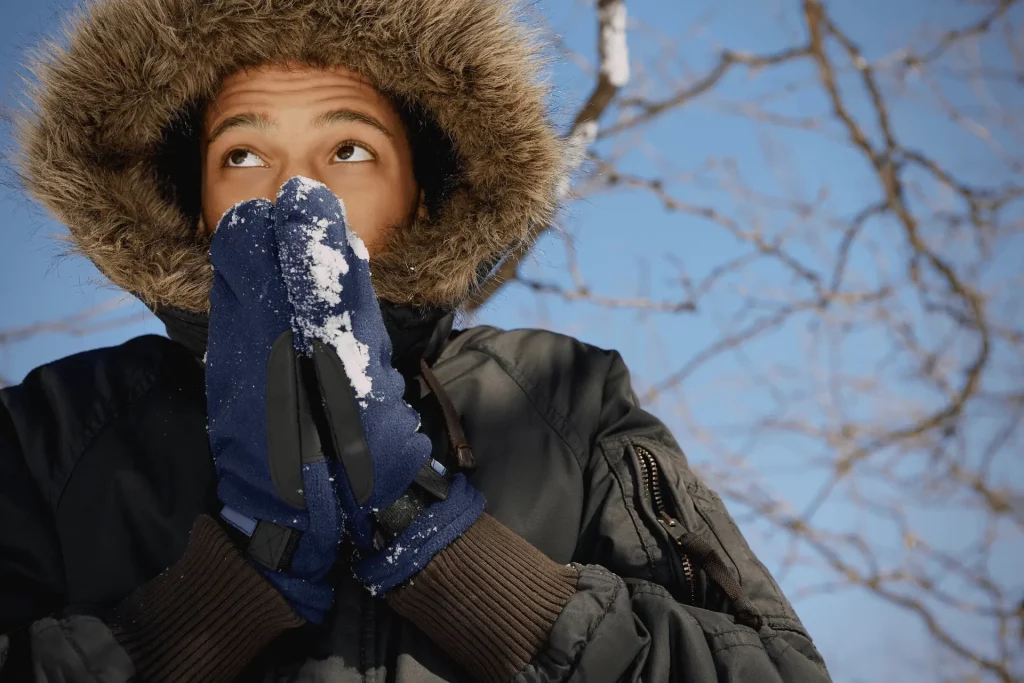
{"left": 110, "top": 515, "right": 304, "bottom": 683}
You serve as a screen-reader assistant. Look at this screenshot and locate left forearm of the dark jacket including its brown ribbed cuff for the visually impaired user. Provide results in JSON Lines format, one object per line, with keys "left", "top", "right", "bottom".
{"left": 0, "top": 515, "right": 303, "bottom": 683}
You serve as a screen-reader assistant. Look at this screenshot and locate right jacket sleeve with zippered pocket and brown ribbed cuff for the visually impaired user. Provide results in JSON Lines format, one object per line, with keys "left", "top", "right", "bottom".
{"left": 388, "top": 354, "right": 830, "bottom": 683}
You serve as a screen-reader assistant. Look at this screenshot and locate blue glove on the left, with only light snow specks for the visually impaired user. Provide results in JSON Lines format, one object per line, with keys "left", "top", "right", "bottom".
{"left": 206, "top": 200, "right": 344, "bottom": 623}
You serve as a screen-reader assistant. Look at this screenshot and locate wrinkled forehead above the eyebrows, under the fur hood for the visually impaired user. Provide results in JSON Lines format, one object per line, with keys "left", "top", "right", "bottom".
{"left": 204, "top": 63, "right": 400, "bottom": 129}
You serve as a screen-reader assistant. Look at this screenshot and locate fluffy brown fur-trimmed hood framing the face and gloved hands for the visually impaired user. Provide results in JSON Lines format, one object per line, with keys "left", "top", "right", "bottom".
{"left": 17, "top": 0, "right": 565, "bottom": 312}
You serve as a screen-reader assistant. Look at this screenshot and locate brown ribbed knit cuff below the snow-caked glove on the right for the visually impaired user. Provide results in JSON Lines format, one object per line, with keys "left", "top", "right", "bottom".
{"left": 387, "top": 514, "right": 578, "bottom": 683}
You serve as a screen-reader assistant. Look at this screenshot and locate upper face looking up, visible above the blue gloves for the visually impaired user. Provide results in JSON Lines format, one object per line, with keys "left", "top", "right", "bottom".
{"left": 202, "top": 65, "right": 422, "bottom": 254}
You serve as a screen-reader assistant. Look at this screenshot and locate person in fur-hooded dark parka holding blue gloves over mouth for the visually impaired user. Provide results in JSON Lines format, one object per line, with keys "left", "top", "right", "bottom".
{"left": 0, "top": 0, "right": 829, "bottom": 683}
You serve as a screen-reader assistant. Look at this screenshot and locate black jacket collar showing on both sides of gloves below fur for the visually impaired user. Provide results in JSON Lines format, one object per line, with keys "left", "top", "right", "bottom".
{"left": 153, "top": 300, "right": 455, "bottom": 376}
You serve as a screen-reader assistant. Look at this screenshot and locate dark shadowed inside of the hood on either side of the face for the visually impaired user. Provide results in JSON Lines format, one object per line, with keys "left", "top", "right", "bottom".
{"left": 154, "top": 93, "right": 461, "bottom": 233}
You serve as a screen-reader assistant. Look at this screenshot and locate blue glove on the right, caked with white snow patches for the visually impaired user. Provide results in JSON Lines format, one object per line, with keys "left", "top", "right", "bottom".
{"left": 275, "top": 177, "right": 484, "bottom": 595}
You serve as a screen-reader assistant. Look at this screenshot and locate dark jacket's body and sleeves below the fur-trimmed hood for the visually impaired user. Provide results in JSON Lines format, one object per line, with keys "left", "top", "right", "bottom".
{"left": 0, "top": 315, "right": 829, "bottom": 683}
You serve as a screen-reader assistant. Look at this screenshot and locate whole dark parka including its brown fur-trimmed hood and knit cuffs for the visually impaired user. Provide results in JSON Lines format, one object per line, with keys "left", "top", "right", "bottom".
{"left": 6, "top": 0, "right": 828, "bottom": 683}
